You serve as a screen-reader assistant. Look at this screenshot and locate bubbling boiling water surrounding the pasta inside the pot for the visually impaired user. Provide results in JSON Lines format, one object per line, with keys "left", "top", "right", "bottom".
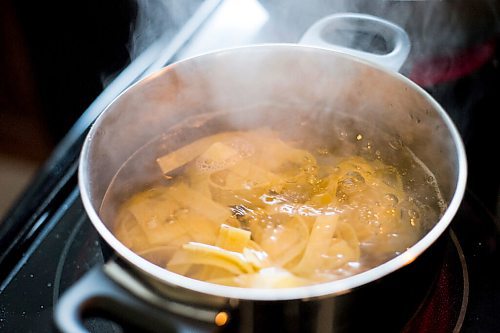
{"left": 100, "top": 107, "right": 446, "bottom": 286}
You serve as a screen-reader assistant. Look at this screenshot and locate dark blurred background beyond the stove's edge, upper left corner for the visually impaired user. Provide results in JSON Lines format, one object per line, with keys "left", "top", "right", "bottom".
{"left": 0, "top": 0, "right": 137, "bottom": 220}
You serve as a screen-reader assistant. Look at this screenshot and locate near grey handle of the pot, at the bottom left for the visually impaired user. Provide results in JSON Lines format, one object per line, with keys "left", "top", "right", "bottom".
{"left": 54, "top": 266, "right": 215, "bottom": 333}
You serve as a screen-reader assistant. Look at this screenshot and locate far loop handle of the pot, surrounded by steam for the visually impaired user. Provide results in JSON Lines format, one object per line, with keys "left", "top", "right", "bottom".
{"left": 299, "top": 13, "right": 410, "bottom": 72}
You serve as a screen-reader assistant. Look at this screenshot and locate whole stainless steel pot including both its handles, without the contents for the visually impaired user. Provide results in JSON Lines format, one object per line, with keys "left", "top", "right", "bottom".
{"left": 56, "top": 14, "right": 466, "bottom": 332}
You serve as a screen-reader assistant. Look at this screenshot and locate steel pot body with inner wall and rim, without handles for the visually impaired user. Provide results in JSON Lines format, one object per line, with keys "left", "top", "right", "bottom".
{"left": 79, "top": 44, "right": 466, "bottom": 331}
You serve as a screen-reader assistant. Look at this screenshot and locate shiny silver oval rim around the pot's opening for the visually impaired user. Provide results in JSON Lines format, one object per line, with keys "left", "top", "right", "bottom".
{"left": 78, "top": 43, "right": 467, "bottom": 301}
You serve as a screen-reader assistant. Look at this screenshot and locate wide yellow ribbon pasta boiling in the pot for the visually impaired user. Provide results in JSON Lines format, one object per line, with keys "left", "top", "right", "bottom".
{"left": 114, "top": 129, "right": 430, "bottom": 288}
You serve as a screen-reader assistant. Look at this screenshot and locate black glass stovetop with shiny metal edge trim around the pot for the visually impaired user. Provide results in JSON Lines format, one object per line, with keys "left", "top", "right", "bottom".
{"left": 0, "top": 0, "right": 500, "bottom": 332}
